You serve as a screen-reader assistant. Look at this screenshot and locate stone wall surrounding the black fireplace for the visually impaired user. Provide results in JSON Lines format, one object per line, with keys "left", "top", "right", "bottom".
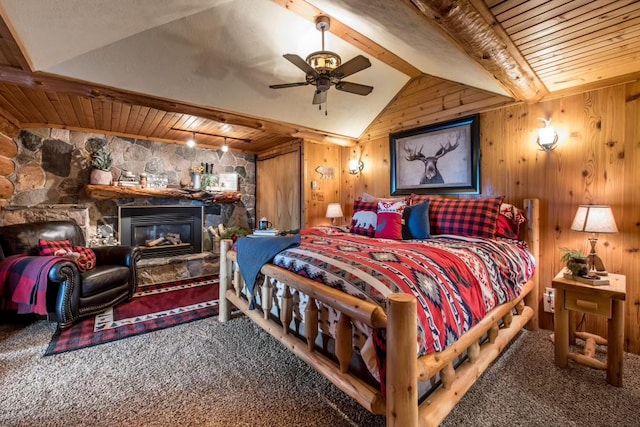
{"left": 0, "top": 128, "right": 256, "bottom": 283}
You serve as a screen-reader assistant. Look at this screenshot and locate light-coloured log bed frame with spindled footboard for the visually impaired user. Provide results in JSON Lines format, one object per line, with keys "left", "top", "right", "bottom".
{"left": 219, "top": 199, "right": 539, "bottom": 427}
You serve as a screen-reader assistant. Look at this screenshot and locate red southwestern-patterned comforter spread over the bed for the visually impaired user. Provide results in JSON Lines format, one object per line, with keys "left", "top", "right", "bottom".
{"left": 274, "top": 227, "right": 535, "bottom": 362}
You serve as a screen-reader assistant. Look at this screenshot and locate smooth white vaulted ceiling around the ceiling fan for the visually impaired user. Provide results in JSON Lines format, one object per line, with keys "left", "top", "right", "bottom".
{"left": 0, "top": 0, "right": 506, "bottom": 138}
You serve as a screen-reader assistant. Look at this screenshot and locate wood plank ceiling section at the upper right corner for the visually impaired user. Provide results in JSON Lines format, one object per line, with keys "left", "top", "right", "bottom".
{"left": 485, "top": 0, "right": 640, "bottom": 93}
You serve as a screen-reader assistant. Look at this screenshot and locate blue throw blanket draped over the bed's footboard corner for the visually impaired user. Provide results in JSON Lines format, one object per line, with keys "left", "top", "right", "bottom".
{"left": 236, "top": 234, "right": 300, "bottom": 309}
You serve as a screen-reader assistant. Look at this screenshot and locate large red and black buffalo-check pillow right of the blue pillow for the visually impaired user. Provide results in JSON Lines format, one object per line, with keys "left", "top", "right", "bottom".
{"left": 429, "top": 196, "right": 503, "bottom": 239}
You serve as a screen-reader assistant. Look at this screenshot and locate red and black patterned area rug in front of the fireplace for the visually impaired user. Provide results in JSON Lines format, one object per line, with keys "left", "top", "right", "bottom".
{"left": 45, "top": 275, "right": 220, "bottom": 356}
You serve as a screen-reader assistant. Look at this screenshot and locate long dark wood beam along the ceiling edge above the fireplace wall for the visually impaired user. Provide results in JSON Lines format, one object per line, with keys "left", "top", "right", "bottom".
{"left": 0, "top": 67, "right": 356, "bottom": 146}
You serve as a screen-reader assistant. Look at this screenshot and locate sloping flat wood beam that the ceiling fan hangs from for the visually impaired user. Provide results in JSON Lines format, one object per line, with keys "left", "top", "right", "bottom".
{"left": 273, "top": 0, "right": 422, "bottom": 77}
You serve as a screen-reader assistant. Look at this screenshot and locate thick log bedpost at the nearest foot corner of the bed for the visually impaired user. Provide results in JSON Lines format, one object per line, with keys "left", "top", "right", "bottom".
{"left": 387, "top": 294, "right": 418, "bottom": 427}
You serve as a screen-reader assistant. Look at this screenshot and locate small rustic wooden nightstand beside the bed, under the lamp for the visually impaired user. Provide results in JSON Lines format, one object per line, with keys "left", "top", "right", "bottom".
{"left": 552, "top": 271, "right": 627, "bottom": 387}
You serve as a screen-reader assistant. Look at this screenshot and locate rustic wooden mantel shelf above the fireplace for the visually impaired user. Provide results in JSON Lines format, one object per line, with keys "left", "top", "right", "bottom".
{"left": 85, "top": 185, "right": 242, "bottom": 204}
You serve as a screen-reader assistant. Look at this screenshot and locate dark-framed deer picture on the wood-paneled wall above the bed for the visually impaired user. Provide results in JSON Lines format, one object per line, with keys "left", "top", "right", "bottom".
{"left": 389, "top": 115, "right": 480, "bottom": 195}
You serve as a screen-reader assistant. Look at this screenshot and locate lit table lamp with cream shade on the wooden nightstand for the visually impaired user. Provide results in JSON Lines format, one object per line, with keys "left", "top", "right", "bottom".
{"left": 571, "top": 205, "right": 618, "bottom": 276}
